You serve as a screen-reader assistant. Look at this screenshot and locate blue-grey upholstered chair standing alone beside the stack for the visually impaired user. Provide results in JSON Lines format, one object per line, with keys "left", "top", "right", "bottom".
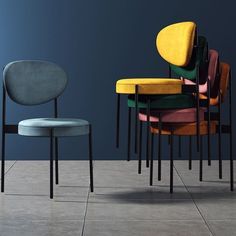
{"left": 1, "top": 61, "right": 93, "bottom": 198}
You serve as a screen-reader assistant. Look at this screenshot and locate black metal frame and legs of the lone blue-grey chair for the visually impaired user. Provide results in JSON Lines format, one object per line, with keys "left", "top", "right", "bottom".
{"left": 1, "top": 84, "right": 94, "bottom": 199}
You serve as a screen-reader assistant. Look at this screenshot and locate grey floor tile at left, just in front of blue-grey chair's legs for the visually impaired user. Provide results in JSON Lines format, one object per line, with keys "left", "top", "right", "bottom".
{"left": 0, "top": 195, "right": 86, "bottom": 221}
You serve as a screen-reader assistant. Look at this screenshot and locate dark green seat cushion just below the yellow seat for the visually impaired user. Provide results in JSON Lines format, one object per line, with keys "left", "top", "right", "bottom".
{"left": 128, "top": 94, "right": 195, "bottom": 109}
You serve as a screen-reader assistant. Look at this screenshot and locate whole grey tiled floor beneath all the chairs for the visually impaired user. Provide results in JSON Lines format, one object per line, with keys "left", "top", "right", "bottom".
{"left": 0, "top": 161, "right": 236, "bottom": 236}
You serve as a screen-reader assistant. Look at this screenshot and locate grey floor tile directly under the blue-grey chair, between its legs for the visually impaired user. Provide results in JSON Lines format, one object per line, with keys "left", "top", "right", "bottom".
{"left": 5, "top": 161, "right": 89, "bottom": 201}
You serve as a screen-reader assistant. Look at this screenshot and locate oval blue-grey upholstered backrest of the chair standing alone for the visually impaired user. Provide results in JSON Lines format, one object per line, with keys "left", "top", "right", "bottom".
{"left": 3, "top": 61, "right": 67, "bottom": 105}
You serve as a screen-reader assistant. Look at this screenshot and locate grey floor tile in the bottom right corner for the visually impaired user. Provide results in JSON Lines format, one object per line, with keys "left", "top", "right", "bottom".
{"left": 207, "top": 220, "right": 236, "bottom": 236}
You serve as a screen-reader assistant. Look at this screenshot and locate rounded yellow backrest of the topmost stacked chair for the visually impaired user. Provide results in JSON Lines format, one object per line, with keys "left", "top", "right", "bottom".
{"left": 156, "top": 22, "right": 196, "bottom": 66}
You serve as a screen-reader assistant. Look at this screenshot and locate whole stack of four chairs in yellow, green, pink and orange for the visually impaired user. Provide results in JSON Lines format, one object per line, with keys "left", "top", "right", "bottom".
{"left": 116, "top": 22, "right": 233, "bottom": 193}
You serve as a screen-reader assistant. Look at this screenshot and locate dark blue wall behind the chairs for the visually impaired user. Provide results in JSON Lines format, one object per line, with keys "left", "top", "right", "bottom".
{"left": 0, "top": 0, "right": 236, "bottom": 159}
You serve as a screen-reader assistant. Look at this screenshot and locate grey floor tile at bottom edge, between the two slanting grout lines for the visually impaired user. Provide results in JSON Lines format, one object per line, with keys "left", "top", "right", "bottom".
{"left": 84, "top": 221, "right": 211, "bottom": 236}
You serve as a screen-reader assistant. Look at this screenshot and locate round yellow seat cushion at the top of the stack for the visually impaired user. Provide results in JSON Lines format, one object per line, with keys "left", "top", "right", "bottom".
{"left": 116, "top": 78, "right": 183, "bottom": 94}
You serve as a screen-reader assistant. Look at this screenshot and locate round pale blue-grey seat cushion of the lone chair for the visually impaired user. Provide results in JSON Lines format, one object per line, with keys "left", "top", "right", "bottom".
{"left": 18, "top": 118, "right": 89, "bottom": 137}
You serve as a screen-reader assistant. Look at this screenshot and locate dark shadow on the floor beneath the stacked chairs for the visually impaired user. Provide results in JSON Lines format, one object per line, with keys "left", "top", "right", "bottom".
{"left": 89, "top": 185, "right": 236, "bottom": 204}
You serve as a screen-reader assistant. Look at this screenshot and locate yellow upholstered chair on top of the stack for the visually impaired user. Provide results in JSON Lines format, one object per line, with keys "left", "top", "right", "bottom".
{"left": 116, "top": 22, "right": 200, "bottom": 173}
